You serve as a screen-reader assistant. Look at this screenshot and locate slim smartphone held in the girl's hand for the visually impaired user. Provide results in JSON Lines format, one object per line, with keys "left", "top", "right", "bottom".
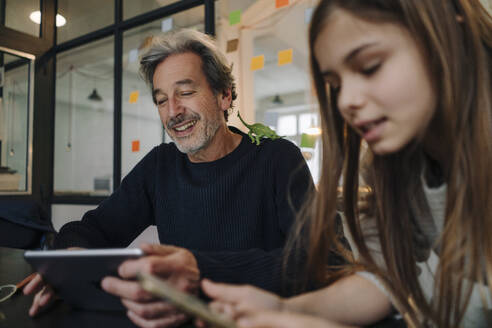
{"left": 137, "top": 272, "right": 236, "bottom": 328}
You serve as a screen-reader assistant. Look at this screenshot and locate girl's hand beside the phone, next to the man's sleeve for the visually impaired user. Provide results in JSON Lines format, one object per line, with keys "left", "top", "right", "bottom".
{"left": 202, "top": 279, "right": 283, "bottom": 319}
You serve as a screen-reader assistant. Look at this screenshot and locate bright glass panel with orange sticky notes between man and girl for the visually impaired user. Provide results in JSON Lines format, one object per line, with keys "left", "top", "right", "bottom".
{"left": 216, "top": 0, "right": 321, "bottom": 183}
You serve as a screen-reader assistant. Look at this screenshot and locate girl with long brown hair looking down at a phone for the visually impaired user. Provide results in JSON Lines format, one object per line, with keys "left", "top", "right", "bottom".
{"left": 203, "top": 0, "right": 492, "bottom": 327}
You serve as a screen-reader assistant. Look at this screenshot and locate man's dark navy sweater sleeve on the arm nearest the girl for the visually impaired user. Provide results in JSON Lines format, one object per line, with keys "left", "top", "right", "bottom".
{"left": 192, "top": 140, "right": 314, "bottom": 296}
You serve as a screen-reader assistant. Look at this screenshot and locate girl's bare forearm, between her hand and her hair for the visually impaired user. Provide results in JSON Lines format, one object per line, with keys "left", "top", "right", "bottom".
{"left": 283, "top": 275, "right": 392, "bottom": 325}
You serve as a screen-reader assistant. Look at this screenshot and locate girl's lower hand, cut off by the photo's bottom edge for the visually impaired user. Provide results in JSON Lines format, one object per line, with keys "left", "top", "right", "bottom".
{"left": 237, "top": 311, "right": 355, "bottom": 328}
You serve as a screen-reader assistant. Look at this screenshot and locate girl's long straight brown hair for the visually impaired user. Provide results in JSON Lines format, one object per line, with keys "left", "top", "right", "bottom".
{"left": 288, "top": 0, "right": 492, "bottom": 327}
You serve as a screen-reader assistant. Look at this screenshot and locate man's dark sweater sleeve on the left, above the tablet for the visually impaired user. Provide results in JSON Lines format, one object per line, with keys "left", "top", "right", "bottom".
{"left": 54, "top": 147, "right": 158, "bottom": 248}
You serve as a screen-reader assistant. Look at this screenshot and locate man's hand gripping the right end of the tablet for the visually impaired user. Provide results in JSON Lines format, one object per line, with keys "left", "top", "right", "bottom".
{"left": 101, "top": 244, "right": 200, "bottom": 328}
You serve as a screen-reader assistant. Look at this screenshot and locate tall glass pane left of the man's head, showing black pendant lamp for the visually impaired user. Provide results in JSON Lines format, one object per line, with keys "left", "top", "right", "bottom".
{"left": 54, "top": 37, "right": 114, "bottom": 195}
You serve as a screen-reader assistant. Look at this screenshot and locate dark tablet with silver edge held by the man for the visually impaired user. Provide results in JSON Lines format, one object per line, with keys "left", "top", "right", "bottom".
{"left": 24, "top": 248, "right": 144, "bottom": 311}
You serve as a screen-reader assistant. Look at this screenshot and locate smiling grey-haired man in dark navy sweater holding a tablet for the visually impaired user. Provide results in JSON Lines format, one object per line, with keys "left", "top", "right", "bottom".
{"left": 27, "top": 30, "right": 313, "bottom": 327}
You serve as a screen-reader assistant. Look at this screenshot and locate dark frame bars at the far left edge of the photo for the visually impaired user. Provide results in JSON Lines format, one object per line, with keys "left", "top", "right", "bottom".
{"left": 0, "top": 0, "right": 56, "bottom": 215}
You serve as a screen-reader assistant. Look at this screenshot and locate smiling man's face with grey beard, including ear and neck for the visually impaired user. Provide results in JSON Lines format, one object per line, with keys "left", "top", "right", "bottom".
{"left": 149, "top": 52, "right": 241, "bottom": 163}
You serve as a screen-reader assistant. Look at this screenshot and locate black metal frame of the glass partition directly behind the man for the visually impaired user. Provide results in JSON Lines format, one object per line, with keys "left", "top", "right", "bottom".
{"left": 51, "top": 0, "right": 215, "bottom": 204}
